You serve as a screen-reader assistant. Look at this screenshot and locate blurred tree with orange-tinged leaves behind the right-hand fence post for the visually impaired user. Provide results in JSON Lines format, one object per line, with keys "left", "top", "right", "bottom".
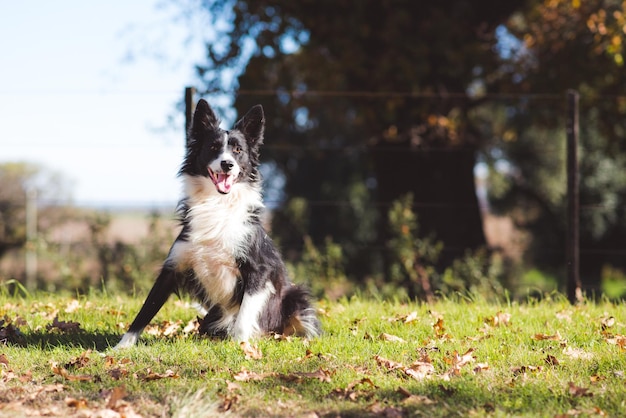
{"left": 493, "top": 0, "right": 626, "bottom": 288}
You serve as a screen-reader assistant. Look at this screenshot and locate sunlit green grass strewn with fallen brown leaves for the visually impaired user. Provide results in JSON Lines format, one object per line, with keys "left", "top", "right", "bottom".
{"left": 0, "top": 293, "right": 626, "bottom": 417}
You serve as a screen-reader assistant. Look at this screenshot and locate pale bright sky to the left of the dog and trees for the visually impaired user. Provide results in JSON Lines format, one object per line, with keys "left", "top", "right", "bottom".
{"left": 0, "top": 0, "right": 210, "bottom": 206}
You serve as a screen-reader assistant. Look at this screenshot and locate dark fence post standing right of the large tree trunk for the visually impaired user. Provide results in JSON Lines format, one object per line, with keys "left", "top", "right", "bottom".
{"left": 566, "top": 90, "right": 583, "bottom": 303}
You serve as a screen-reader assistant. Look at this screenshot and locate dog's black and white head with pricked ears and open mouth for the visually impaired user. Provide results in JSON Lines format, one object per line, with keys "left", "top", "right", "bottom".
{"left": 180, "top": 100, "right": 265, "bottom": 194}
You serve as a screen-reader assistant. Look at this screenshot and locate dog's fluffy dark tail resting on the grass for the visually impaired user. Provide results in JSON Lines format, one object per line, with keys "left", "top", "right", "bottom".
{"left": 282, "top": 286, "right": 322, "bottom": 338}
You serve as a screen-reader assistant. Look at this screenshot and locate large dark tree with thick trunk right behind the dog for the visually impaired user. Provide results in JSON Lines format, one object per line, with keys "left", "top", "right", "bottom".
{"left": 180, "top": 0, "right": 522, "bottom": 284}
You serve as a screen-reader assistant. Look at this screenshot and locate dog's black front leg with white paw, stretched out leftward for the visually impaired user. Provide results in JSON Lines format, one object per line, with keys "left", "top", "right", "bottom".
{"left": 115, "top": 264, "right": 176, "bottom": 349}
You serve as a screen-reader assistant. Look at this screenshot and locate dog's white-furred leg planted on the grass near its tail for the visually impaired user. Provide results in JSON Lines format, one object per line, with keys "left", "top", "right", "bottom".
{"left": 232, "top": 282, "right": 276, "bottom": 341}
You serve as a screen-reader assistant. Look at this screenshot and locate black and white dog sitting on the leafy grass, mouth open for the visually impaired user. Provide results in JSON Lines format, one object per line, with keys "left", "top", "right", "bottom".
{"left": 116, "top": 100, "right": 320, "bottom": 348}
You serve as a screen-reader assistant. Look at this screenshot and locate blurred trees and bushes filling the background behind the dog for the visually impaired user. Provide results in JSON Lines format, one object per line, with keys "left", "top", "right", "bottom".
{"left": 0, "top": 0, "right": 626, "bottom": 300}
